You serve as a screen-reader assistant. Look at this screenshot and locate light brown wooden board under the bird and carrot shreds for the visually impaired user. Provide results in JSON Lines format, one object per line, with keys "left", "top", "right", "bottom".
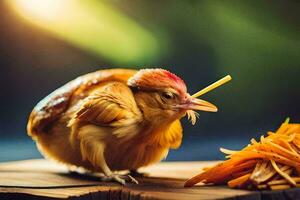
{"left": 0, "top": 160, "right": 300, "bottom": 200}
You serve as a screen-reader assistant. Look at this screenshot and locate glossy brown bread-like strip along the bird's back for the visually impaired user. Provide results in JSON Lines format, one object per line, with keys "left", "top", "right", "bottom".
{"left": 27, "top": 69, "right": 136, "bottom": 137}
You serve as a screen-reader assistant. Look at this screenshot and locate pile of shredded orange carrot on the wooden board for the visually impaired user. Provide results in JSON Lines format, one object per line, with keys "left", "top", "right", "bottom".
{"left": 185, "top": 119, "right": 300, "bottom": 190}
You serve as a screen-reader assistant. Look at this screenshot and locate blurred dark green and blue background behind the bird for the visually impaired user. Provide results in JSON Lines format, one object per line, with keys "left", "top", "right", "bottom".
{"left": 0, "top": 0, "right": 300, "bottom": 161}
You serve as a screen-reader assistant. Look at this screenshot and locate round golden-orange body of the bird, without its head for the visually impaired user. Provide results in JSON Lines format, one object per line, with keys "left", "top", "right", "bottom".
{"left": 28, "top": 69, "right": 182, "bottom": 172}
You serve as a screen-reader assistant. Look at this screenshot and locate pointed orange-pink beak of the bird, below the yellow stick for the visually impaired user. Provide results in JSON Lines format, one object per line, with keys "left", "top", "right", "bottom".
{"left": 180, "top": 95, "right": 218, "bottom": 112}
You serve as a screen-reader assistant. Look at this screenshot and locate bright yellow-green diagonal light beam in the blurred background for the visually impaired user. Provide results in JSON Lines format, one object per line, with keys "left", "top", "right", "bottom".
{"left": 8, "top": 0, "right": 160, "bottom": 64}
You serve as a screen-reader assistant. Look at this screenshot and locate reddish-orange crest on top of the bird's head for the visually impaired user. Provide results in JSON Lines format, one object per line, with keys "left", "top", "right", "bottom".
{"left": 128, "top": 69, "right": 186, "bottom": 94}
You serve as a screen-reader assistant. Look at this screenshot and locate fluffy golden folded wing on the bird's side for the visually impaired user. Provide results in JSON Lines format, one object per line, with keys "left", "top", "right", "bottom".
{"left": 69, "top": 82, "right": 142, "bottom": 137}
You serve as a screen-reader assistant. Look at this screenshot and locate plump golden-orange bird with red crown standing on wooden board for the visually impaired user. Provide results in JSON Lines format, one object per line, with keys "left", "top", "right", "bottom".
{"left": 27, "top": 68, "right": 217, "bottom": 184}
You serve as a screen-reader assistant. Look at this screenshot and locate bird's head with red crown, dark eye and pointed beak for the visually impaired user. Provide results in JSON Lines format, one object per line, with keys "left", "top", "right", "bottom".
{"left": 128, "top": 69, "right": 217, "bottom": 124}
